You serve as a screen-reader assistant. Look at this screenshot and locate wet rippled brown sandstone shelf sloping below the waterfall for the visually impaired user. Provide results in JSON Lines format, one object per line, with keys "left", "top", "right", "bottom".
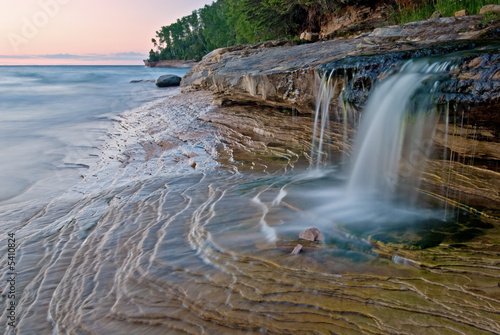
{"left": 2, "top": 87, "right": 500, "bottom": 334}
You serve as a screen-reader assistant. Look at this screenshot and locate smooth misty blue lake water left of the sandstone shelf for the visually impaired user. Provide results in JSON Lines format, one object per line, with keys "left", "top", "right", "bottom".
{"left": 0, "top": 66, "right": 187, "bottom": 202}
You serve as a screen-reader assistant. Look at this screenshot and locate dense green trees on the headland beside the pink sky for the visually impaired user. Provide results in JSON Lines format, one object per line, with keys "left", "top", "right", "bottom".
{"left": 149, "top": 0, "right": 369, "bottom": 61}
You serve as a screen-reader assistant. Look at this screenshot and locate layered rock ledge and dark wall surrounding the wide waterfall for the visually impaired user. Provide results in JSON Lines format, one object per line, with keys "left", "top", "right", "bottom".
{"left": 181, "top": 16, "right": 500, "bottom": 217}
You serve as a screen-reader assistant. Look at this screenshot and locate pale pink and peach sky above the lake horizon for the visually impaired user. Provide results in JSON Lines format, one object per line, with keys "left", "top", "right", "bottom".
{"left": 0, "top": 0, "right": 213, "bottom": 65}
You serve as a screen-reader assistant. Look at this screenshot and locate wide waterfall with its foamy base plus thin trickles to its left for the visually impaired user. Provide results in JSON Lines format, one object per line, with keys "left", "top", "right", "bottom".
{"left": 304, "top": 59, "right": 458, "bottom": 229}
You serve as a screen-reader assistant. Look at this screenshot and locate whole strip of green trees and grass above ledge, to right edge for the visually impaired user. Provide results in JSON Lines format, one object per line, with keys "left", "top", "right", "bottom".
{"left": 148, "top": 0, "right": 498, "bottom": 62}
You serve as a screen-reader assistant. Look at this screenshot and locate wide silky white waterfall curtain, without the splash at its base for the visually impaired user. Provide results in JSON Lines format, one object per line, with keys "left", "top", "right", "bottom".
{"left": 347, "top": 60, "right": 450, "bottom": 200}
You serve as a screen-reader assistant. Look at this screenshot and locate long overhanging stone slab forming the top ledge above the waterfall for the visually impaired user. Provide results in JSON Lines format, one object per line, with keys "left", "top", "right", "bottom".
{"left": 181, "top": 16, "right": 500, "bottom": 113}
